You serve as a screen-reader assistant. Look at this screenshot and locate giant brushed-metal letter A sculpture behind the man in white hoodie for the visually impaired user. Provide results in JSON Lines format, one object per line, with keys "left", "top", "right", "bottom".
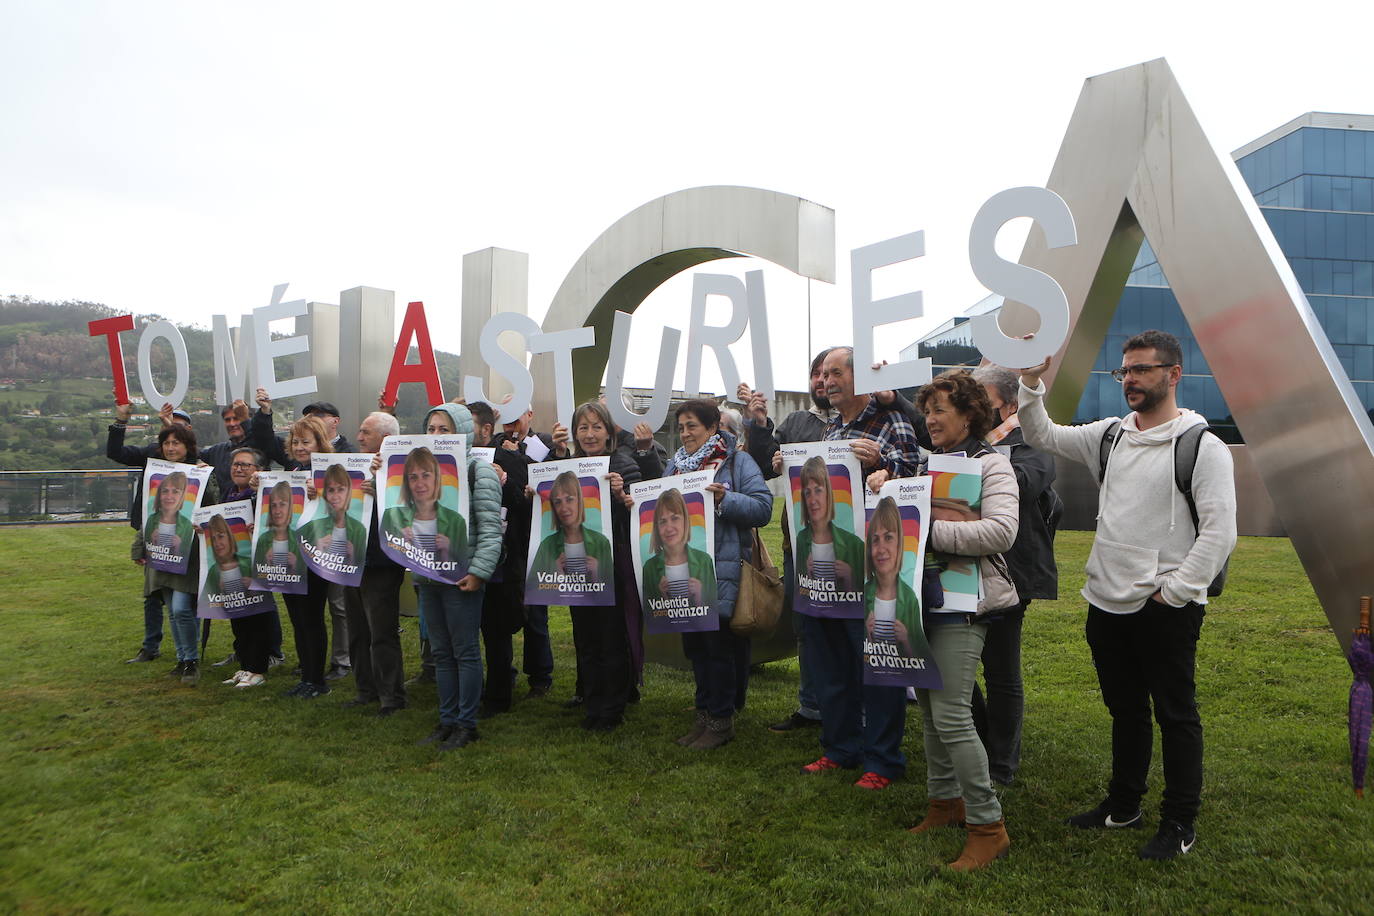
{"left": 1002, "top": 59, "right": 1374, "bottom": 644}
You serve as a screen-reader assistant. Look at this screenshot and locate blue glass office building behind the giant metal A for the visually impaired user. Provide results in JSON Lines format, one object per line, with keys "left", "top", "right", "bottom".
{"left": 903, "top": 113, "right": 1374, "bottom": 442}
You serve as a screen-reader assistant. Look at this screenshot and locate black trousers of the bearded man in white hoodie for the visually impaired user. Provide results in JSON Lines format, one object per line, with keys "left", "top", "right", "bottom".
{"left": 1087, "top": 600, "right": 1204, "bottom": 824}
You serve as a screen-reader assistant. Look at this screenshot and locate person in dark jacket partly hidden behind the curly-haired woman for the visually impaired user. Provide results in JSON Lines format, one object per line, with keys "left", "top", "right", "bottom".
{"left": 973, "top": 365, "right": 1063, "bottom": 786}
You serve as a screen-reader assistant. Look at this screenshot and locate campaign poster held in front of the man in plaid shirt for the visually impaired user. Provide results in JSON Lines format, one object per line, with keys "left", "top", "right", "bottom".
{"left": 782, "top": 439, "right": 864, "bottom": 619}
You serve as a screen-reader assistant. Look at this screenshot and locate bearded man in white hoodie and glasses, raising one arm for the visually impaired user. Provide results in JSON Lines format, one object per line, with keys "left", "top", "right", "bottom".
{"left": 1017, "top": 331, "right": 1235, "bottom": 860}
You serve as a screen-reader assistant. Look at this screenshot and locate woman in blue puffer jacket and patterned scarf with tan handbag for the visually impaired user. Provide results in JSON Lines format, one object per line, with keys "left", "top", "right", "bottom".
{"left": 664, "top": 400, "right": 772, "bottom": 750}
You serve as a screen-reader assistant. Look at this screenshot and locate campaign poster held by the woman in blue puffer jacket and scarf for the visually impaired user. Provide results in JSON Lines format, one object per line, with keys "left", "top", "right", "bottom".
{"left": 629, "top": 471, "right": 720, "bottom": 633}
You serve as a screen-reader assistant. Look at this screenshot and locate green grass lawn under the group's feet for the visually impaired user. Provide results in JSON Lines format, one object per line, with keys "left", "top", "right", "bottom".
{"left": 0, "top": 525, "right": 1374, "bottom": 913}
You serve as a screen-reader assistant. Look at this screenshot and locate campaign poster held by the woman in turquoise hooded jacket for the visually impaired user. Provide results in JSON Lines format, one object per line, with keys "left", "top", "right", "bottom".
{"left": 376, "top": 435, "right": 469, "bottom": 584}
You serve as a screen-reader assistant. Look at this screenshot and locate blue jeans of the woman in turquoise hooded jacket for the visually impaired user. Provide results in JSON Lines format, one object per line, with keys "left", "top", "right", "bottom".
{"left": 419, "top": 585, "right": 486, "bottom": 728}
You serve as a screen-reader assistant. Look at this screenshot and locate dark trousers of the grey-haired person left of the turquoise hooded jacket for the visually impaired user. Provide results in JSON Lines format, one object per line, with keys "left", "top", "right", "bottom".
{"left": 344, "top": 564, "right": 405, "bottom": 709}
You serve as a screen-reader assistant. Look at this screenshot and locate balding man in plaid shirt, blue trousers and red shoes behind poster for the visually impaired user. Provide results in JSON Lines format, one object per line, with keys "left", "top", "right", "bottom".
{"left": 801, "top": 346, "right": 921, "bottom": 790}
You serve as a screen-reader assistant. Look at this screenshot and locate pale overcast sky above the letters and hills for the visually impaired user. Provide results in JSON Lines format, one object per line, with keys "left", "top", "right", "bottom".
{"left": 0, "top": 0, "right": 1374, "bottom": 390}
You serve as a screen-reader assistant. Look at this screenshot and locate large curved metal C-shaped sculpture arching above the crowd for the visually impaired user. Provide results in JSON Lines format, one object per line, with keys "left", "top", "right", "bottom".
{"left": 530, "top": 187, "right": 835, "bottom": 417}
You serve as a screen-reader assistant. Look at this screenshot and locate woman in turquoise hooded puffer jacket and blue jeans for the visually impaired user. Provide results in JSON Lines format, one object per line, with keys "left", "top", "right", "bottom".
{"left": 415, "top": 404, "right": 502, "bottom": 751}
